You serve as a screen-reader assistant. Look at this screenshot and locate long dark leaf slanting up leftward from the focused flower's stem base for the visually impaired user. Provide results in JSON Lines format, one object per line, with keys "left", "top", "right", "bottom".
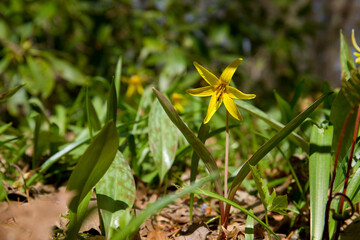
{"left": 153, "top": 88, "right": 224, "bottom": 217}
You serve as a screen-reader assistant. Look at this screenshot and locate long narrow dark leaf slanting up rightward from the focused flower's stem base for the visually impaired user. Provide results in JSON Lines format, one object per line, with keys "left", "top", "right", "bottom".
{"left": 225, "top": 93, "right": 331, "bottom": 221}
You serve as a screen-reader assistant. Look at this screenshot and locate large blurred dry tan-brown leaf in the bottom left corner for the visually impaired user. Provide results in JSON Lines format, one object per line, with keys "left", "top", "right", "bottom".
{"left": 0, "top": 192, "right": 72, "bottom": 240}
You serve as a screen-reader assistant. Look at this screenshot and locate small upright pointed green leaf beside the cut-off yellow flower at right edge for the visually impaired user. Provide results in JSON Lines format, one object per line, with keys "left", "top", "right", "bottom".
{"left": 340, "top": 30, "right": 356, "bottom": 80}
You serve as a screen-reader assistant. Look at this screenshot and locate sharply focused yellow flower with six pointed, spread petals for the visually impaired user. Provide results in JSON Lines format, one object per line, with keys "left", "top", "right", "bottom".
{"left": 187, "top": 58, "right": 256, "bottom": 123}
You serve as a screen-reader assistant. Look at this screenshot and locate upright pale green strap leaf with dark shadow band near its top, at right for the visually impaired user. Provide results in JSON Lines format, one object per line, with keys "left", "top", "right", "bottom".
{"left": 309, "top": 125, "right": 333, "bottom": 239}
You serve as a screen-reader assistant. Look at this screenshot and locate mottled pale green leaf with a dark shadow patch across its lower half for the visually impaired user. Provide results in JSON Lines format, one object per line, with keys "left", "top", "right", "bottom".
{"left": 96, "top": 151, "right": 136, "bottom": 239}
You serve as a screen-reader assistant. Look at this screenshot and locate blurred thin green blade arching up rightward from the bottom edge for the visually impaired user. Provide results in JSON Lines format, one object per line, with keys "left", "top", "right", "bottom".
{"left": 111, "top": 175, "right": 216, "bottom": 240}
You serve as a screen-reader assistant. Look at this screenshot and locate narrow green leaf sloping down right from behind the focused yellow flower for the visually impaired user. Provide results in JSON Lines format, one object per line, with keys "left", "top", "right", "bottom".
{"left": 235, "top": 99, "right": 309, "bottom": 152}
